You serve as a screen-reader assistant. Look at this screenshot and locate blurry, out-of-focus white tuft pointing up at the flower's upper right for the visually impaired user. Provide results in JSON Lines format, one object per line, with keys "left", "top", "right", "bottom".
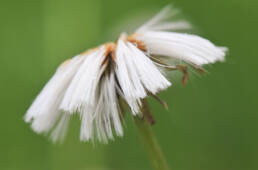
{"left": 135, "top": 6, "right": 191, "bottom": 33}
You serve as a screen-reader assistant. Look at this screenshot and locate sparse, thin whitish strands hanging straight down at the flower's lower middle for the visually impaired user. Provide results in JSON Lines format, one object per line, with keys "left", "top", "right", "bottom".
{"left": 80, "top": 72, "right": 123, "bottom": 143}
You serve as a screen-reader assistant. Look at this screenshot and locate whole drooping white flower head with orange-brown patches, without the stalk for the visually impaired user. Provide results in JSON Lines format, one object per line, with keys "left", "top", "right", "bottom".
{"left": 25, "top": 5, "right": 226, "bottom": 142}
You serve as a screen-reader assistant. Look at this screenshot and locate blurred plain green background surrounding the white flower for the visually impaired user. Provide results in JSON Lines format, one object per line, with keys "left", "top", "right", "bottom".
{"left": 0, "top": 0, "right": 258, "bottom": 170}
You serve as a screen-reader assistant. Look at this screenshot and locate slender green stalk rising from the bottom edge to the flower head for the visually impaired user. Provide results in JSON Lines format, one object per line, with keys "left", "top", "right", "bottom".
{"left": 134, "top": 101, "right": 170, "bottom": 170}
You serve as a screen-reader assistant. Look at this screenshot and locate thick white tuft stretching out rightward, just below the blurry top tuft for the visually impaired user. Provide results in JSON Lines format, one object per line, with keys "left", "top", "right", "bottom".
{"left": 136, "top": 31, "right": 226, "bottom": 66}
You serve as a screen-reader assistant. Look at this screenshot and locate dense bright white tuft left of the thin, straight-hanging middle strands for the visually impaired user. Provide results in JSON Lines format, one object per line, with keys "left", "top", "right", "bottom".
{"left": 60, "top": 47, "right": 105, "bottom": 114}
